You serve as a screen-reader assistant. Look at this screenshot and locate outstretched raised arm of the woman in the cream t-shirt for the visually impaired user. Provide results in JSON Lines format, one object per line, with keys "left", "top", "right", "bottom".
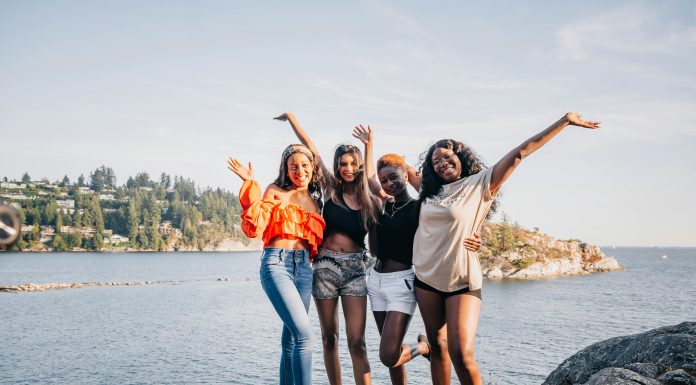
{"left": 489, "top": 112, "right": 599, "bottom": 194}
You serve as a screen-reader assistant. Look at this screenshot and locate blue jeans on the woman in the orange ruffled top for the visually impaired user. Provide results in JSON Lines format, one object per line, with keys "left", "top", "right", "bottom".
{"left": 259, "top": 247, "right": 314, "bottom": 385}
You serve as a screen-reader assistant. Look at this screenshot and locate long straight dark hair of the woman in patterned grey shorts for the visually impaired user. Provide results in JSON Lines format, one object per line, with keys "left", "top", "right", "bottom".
{"left": 328, "top": 144, "right": 380, "bottom": 230}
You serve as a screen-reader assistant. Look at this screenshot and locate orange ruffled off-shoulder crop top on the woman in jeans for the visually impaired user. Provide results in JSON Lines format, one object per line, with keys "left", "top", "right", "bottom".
{"left": 239, "top": 180, "right": 326, "bottom": 258}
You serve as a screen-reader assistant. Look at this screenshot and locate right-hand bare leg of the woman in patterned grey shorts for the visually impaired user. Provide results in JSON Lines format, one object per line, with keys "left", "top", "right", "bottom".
{"left": 341, "top": 295, "right": 372, "bottom": 385}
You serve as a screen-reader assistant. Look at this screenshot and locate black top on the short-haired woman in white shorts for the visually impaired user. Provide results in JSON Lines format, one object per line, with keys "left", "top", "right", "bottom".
{"left": 376, "top": 200, "right": 420, "bottom": 265}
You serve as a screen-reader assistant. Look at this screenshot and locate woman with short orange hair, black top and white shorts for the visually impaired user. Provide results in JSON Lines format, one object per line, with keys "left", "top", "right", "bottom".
{"left": 355, "top": 126, "right": 481, "bottom": 384}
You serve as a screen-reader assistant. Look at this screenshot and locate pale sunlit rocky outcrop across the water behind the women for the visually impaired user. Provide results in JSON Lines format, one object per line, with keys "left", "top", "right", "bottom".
{"left": 479, "top": 224, "right": 622, "bottom": 279}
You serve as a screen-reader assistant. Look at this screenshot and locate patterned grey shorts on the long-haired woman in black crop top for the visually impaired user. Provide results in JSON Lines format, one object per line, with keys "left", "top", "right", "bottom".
{"left": 312, "top": 249, "right": 367, "bottom": 299}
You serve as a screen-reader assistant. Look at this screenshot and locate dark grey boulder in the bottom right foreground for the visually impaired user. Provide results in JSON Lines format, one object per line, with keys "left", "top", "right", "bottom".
{"left": 543, "top": 322, "right": 696, "bottom": 385}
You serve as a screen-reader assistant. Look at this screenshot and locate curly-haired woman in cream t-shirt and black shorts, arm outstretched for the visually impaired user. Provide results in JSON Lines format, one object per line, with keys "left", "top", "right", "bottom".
{"left": 413, "top": 112, "right": 599, "bottom": 385}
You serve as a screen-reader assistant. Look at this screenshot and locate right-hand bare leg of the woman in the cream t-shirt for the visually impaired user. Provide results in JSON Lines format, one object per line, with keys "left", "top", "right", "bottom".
{"left": 445, "top": 294, "right": 483, "bottom": 385}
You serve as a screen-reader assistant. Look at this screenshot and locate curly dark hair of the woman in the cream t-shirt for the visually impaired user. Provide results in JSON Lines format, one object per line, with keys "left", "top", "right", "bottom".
{"left": 418, "top": 139, "right": 498, "bottom": 217}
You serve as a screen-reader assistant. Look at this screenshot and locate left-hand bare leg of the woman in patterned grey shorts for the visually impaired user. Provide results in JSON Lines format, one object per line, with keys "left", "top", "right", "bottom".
{"left": 314, "top": 298, "right": 345, "bottom": 385}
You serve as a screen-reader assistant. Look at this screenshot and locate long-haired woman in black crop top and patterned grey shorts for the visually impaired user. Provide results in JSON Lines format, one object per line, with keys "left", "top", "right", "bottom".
{"left": 276, "top": 112, "right": 380, "bottom": 385}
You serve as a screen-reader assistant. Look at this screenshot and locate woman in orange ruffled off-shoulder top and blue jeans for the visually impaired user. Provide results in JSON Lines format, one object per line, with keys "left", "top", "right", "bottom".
{"left": 228, "top": 144, "right": 326, "bottom": 385}
